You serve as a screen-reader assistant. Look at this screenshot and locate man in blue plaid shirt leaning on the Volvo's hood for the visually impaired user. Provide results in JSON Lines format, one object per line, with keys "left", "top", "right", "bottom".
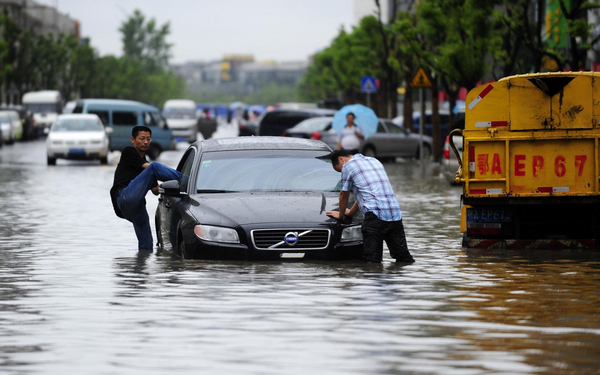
{"left": 327, "top": 150, "right": 414, "bottom": 263}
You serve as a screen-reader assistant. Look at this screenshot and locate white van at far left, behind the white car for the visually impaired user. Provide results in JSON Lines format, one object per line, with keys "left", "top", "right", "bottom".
{"left": 23, "top": 90, "right": 62, "bottom": 134}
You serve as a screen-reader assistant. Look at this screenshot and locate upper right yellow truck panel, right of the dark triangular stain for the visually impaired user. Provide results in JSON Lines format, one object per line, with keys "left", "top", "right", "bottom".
{"left": 552, "top": 76, "right": 593, "bottom": 129}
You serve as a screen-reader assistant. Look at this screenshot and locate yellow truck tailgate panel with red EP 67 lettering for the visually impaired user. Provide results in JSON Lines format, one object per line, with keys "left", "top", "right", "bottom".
{"left": 509, "top": 139, "right": 596, "bottom": 195}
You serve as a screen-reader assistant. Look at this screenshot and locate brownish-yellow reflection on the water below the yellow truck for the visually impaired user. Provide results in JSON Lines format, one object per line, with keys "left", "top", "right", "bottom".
{"left": 458, "top": 249, "right": 600, "bottom": 372}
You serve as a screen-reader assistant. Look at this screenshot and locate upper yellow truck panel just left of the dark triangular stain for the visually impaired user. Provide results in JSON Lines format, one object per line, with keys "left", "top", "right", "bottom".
{"left": 509, "top": 77, "right": 552, "bottom": 130}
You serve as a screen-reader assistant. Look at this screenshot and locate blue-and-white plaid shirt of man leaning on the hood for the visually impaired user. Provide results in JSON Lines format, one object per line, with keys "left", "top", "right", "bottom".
{"left": 341, "top": 154, "right": 402, "bottom": 221}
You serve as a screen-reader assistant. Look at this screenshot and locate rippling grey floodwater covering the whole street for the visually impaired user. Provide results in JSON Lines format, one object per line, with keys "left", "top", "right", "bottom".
{"left": 0, "top": 134, "right": 600, "bottom": 374}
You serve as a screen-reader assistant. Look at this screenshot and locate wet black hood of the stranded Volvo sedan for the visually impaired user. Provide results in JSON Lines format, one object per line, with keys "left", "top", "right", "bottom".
{"left": 190, "top": 192, "right": 346, "bottom": 227}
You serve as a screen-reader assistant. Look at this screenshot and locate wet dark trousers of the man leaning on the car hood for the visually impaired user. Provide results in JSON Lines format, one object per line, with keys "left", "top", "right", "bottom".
{"left": 362, "top": 212, "right": 414, "bottom": 263}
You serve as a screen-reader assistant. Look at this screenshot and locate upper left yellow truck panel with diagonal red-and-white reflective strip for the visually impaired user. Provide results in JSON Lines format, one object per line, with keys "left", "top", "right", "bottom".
{"left": 465, "top": 82, "right": 509, "bottom": 131}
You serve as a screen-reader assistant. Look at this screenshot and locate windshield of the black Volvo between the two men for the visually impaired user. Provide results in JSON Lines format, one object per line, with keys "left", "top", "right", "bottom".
{"left": 196, "top": 150, "right": 340, "bottom": 193}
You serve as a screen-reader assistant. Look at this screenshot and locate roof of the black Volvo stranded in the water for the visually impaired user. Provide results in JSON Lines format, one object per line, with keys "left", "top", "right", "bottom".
{"left": 194, "top": 137, "right": 330, "bottom": 152}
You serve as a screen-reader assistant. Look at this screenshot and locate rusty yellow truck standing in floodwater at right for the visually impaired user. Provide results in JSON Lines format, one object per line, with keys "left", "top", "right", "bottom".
{"left": 450, "top": 72, "right": 600, "bottom": 249}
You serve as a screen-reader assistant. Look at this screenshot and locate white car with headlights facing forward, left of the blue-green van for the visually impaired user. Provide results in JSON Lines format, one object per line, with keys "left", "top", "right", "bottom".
{"left": 46, "top": 114, "right": 108, "bottom": 165}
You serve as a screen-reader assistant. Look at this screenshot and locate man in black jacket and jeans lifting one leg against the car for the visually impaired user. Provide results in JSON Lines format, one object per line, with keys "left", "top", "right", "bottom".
{"left": 110, "top": 126, "right": 179, "bottom": 251}
